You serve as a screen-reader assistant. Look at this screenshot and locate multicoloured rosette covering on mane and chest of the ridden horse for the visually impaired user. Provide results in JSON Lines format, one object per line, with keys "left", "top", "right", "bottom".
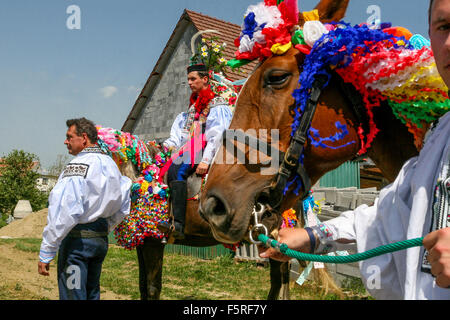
{"left": 97, "top": 126, "right": 170, "bottom": 250}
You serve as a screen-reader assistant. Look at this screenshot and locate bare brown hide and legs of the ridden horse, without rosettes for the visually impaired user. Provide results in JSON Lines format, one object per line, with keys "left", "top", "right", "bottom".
{"left": 118, "top": 134, "right": 298, "bottom": 300}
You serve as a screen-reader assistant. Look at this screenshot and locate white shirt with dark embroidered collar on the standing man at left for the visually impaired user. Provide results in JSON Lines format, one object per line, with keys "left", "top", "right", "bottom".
{"left": 39, "top": 148, "right": 132, "bottom": 263}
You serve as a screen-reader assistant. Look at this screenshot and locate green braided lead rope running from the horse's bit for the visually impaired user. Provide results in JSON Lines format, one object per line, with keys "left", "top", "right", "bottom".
{"left": 258, "top": 234, "right": 423, "bottom": 263}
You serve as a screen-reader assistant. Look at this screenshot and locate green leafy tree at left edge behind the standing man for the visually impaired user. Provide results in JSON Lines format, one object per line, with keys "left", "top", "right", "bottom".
{"left": 0, "top": 150, "right": 48, "bottom": 216}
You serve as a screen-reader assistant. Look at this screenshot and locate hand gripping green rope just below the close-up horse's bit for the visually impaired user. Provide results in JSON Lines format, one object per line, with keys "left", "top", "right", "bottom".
{"left": 258, "top": 228, "right": 310, "bottom": 262}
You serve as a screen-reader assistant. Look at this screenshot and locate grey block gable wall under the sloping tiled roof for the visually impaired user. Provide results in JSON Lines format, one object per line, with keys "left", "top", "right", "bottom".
{"left": 132, "top": 24, "right": 197, "bottom": 142}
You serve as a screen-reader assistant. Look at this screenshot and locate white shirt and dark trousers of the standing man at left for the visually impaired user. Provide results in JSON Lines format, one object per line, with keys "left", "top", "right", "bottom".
{"left": 39, "top": 146, "right": 131, "bottom": 300}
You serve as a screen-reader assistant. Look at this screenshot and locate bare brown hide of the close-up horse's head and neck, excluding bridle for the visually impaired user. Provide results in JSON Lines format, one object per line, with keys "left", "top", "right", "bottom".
{"left": 200, "top": 0, "right": 418, "bottom": 248}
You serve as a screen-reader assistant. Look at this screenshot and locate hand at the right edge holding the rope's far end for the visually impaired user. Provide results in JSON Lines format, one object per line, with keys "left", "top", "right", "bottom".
{"left": 423, "top": 228, "right": 450, "bottom": 288}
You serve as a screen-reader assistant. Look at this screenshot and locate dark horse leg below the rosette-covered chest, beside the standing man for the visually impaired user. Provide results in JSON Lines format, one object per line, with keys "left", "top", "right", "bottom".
{"left": 136, "top": 238, "right": 164, "bottom": 300}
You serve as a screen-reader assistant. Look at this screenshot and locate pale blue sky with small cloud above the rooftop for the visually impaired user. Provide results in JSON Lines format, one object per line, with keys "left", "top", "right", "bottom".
{"left": 0, "top": 0, "right": 428, "bottom": 168}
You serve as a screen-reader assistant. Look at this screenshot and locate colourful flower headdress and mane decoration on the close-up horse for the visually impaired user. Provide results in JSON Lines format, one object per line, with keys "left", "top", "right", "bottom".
{"left": 228, "top": 0, "right": 450, "bottom": 154}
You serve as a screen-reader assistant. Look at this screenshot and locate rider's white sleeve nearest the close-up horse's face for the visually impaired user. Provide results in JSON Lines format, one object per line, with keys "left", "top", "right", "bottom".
{"left": 202, "top": 105, "right": 233, "bottom": 164}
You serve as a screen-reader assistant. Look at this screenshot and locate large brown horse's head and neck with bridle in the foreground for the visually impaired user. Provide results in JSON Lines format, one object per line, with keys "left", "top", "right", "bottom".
{"left": 199, "top": 0, "right": 448, "bottom": 284}
